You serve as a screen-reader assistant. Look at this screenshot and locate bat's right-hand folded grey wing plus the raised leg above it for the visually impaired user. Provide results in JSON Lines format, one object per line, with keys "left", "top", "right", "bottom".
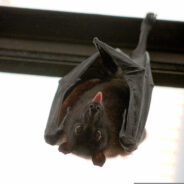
{"left": 94, "top": 13, "right": 155, "bottom": 152}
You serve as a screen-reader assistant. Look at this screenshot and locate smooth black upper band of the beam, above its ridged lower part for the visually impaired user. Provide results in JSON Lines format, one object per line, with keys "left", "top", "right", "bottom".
{"left": 0, "top": 7, "right": 184, "bottom": 52}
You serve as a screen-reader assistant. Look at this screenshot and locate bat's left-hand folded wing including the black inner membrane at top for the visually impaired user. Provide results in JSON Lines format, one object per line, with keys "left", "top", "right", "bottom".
{"left": 44, "top": 50, "right": 117, "bottom": 145}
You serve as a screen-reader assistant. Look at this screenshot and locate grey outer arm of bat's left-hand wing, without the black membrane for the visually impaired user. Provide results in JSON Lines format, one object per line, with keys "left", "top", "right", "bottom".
{"left": 44, "top": 53, "right": 98, "bottom": 145}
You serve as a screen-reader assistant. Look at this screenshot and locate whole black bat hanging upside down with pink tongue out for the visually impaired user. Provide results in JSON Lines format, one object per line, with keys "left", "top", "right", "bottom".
{"left": 45, "top": 13, "right": 156, "bottom": 166}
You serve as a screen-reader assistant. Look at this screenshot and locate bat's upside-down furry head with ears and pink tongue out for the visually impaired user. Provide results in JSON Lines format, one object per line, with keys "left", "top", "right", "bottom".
{"left": 59, "top": 92, "right": 109, "bottom": 166}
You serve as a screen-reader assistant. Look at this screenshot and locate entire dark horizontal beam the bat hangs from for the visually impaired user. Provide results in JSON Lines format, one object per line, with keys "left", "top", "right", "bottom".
{"left": 0, "top": 7, "right": 184, "bottom": 87}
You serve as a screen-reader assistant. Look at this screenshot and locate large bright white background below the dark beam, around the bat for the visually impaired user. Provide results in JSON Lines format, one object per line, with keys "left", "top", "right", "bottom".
{"left": 0, "top": 73, "right": 184, "bottom": 184}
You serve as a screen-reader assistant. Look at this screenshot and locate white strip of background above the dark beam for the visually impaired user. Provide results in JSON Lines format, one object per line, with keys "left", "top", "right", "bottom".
{"left": 0, "top": 0, "right": 184, "bottom": 21}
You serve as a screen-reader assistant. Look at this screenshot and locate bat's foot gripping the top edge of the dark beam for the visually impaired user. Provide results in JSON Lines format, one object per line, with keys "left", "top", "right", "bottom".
{"left": 141, "top": 13, "right": 156, "bottom": 30}
